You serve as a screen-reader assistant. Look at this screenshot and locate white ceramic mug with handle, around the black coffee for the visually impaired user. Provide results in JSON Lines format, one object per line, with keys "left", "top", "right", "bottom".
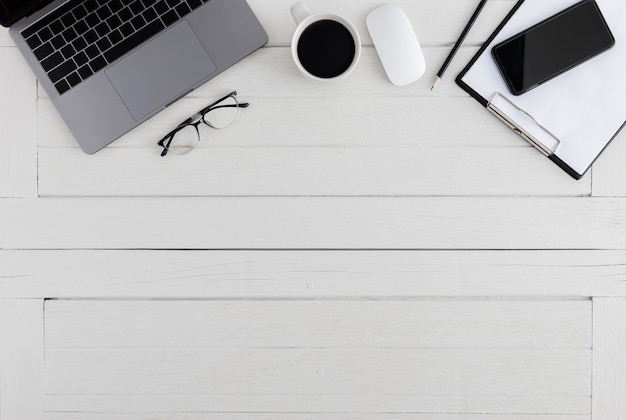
{"left": 291, "top": 2, "right": 361, "bottom": 82}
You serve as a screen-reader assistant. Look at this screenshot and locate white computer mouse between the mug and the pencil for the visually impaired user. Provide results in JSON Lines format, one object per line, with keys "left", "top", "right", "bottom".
{"left": 367, "top": 5, "right": 426, "bottom": 86}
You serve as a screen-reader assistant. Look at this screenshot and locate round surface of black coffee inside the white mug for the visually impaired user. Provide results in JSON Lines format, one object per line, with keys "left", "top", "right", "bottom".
{"left": 298, "top": 19, "right": 356, "bottom": 79}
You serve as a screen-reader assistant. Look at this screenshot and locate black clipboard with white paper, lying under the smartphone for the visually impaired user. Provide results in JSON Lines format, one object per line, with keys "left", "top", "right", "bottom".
{"left": 456, "top": 0, "right": 626, "bottom": 179}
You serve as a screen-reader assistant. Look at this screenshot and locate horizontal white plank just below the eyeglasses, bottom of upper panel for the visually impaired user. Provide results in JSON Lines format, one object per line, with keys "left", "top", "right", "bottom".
{"left": 39, "top": 147, "right": 591, "bottom": 197}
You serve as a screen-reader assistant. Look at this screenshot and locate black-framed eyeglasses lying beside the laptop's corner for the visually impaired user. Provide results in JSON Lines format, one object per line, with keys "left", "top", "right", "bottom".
{"left": 158, "top": 91, "right": 250, "bottom": 156}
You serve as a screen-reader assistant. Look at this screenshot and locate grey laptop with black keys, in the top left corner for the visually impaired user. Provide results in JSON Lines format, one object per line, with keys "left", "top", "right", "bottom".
{"left": 0, "top": 0, "right": 268, "bottom": 154}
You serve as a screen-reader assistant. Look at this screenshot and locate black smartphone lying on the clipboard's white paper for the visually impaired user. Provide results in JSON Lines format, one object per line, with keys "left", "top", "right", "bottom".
{"left": 491, "top": 0, "right": 615, "bottom": 95}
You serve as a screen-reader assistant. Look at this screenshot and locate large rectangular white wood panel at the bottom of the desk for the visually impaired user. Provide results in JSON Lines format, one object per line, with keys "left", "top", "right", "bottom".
{"left": 46, "top": 300, "right": 591, "bottom": 415}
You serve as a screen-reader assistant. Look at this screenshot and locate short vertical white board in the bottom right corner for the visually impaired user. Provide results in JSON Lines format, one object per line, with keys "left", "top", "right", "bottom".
{"left": 592, "top": 298, "right": 626, "bottom": 420}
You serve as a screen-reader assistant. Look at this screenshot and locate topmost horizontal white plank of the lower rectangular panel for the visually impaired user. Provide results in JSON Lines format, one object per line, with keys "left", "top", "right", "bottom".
{"left": 46, "top": 300, "right": 591, "bottom": 349}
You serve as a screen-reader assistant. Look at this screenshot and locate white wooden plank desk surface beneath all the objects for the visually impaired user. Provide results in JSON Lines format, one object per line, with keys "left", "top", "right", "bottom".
{"left": 0, "top": 0, "right": 626, "bottom": 420}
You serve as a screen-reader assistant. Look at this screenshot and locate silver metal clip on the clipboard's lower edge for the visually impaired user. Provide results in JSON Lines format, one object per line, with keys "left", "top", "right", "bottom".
{"left": 487, "top": 93, "right": 561, "bottom": 157}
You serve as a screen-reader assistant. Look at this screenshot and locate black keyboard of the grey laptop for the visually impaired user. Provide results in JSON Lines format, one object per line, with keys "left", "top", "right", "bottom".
{"left": 22, "top": 0, "right": 209, "bottom": 94}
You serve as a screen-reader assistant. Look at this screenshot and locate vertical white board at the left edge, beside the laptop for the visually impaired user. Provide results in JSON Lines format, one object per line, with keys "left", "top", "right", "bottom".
{"left": 0, "top": 47, "right": 37, "bottom": 197}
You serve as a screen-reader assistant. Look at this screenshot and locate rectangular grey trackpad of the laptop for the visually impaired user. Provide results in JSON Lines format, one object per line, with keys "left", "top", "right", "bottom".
{"left": 105, "top": 21, "right": 217, "bottom": 120}
